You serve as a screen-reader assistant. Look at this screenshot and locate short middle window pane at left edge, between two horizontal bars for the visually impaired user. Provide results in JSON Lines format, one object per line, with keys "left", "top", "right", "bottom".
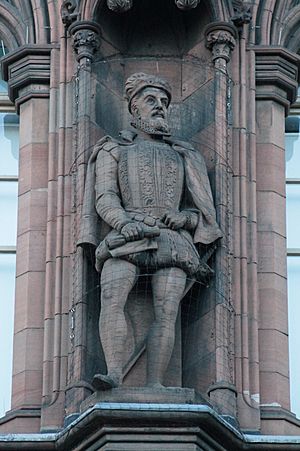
{"left": 0, "top": 182, "right": 18, "bottom": 246}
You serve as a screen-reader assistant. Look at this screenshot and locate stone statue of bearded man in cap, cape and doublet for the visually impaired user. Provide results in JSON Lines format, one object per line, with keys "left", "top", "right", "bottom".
{"left": 80, "top": 73, "right": 222, "bottom": 390}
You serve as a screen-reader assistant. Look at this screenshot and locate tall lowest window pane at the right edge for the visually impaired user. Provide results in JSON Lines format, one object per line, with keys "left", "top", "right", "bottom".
{"left": 288, "top": 257, "right": 300, "bottom": 418}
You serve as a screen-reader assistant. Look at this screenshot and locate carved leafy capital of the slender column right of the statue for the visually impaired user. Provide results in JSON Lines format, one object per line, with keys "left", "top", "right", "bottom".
{"left": 205, "top": 22, "right": 236, "bottom": 63}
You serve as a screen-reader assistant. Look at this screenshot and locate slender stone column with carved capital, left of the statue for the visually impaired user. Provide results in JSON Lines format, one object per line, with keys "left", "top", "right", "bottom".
{"left": 67, "top": 21, "right": 100, "bottom": 414}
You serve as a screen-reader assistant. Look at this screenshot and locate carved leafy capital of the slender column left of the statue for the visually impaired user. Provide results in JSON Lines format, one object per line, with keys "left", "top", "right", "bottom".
{"left": 69, "top": 20, "right": 100, "bottom": 61}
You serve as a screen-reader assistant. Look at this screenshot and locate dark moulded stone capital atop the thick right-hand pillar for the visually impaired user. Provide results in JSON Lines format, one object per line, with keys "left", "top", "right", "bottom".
{"left": 254, "top": 46, "right": 300, "bottom": 113}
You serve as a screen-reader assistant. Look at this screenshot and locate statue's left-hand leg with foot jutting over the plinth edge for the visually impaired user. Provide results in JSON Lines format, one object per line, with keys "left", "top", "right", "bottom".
{"left": 93, "top": 258, "right": 138, "bottom": 390}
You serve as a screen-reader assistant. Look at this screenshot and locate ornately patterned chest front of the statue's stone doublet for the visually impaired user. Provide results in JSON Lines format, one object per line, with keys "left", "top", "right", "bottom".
{"left": 118, "top": 141, "right": 184, "bottom": 219}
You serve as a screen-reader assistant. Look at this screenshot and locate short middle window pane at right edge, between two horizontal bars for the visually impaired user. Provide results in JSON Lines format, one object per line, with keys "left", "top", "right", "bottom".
{"left": 286, "top": 184, "right": 300, "bottom": 248}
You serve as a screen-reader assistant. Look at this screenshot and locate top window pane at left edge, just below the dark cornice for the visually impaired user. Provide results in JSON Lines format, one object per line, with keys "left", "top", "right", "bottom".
{"left": 0, "top": 113, "right": 19, "bottom": 176}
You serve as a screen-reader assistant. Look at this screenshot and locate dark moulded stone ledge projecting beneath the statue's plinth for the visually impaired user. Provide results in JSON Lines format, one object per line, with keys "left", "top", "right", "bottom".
{"left": 0, "top": 403, "right": 300, "bottom": 451}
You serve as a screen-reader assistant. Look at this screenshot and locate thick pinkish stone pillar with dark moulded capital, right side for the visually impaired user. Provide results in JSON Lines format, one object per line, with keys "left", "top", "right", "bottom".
{"left": 254, "top": 46, "right": 300, "bottom": 434}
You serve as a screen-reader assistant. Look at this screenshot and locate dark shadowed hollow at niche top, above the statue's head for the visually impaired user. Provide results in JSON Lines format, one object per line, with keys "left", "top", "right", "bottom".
{"left": 93, "top": 0, "right": 214, "bottom": 56}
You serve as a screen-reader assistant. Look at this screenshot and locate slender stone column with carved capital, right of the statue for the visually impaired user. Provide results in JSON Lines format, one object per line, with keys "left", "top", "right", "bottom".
{"left": 205, "top": 22, "right": 236, "bottom": 416}
